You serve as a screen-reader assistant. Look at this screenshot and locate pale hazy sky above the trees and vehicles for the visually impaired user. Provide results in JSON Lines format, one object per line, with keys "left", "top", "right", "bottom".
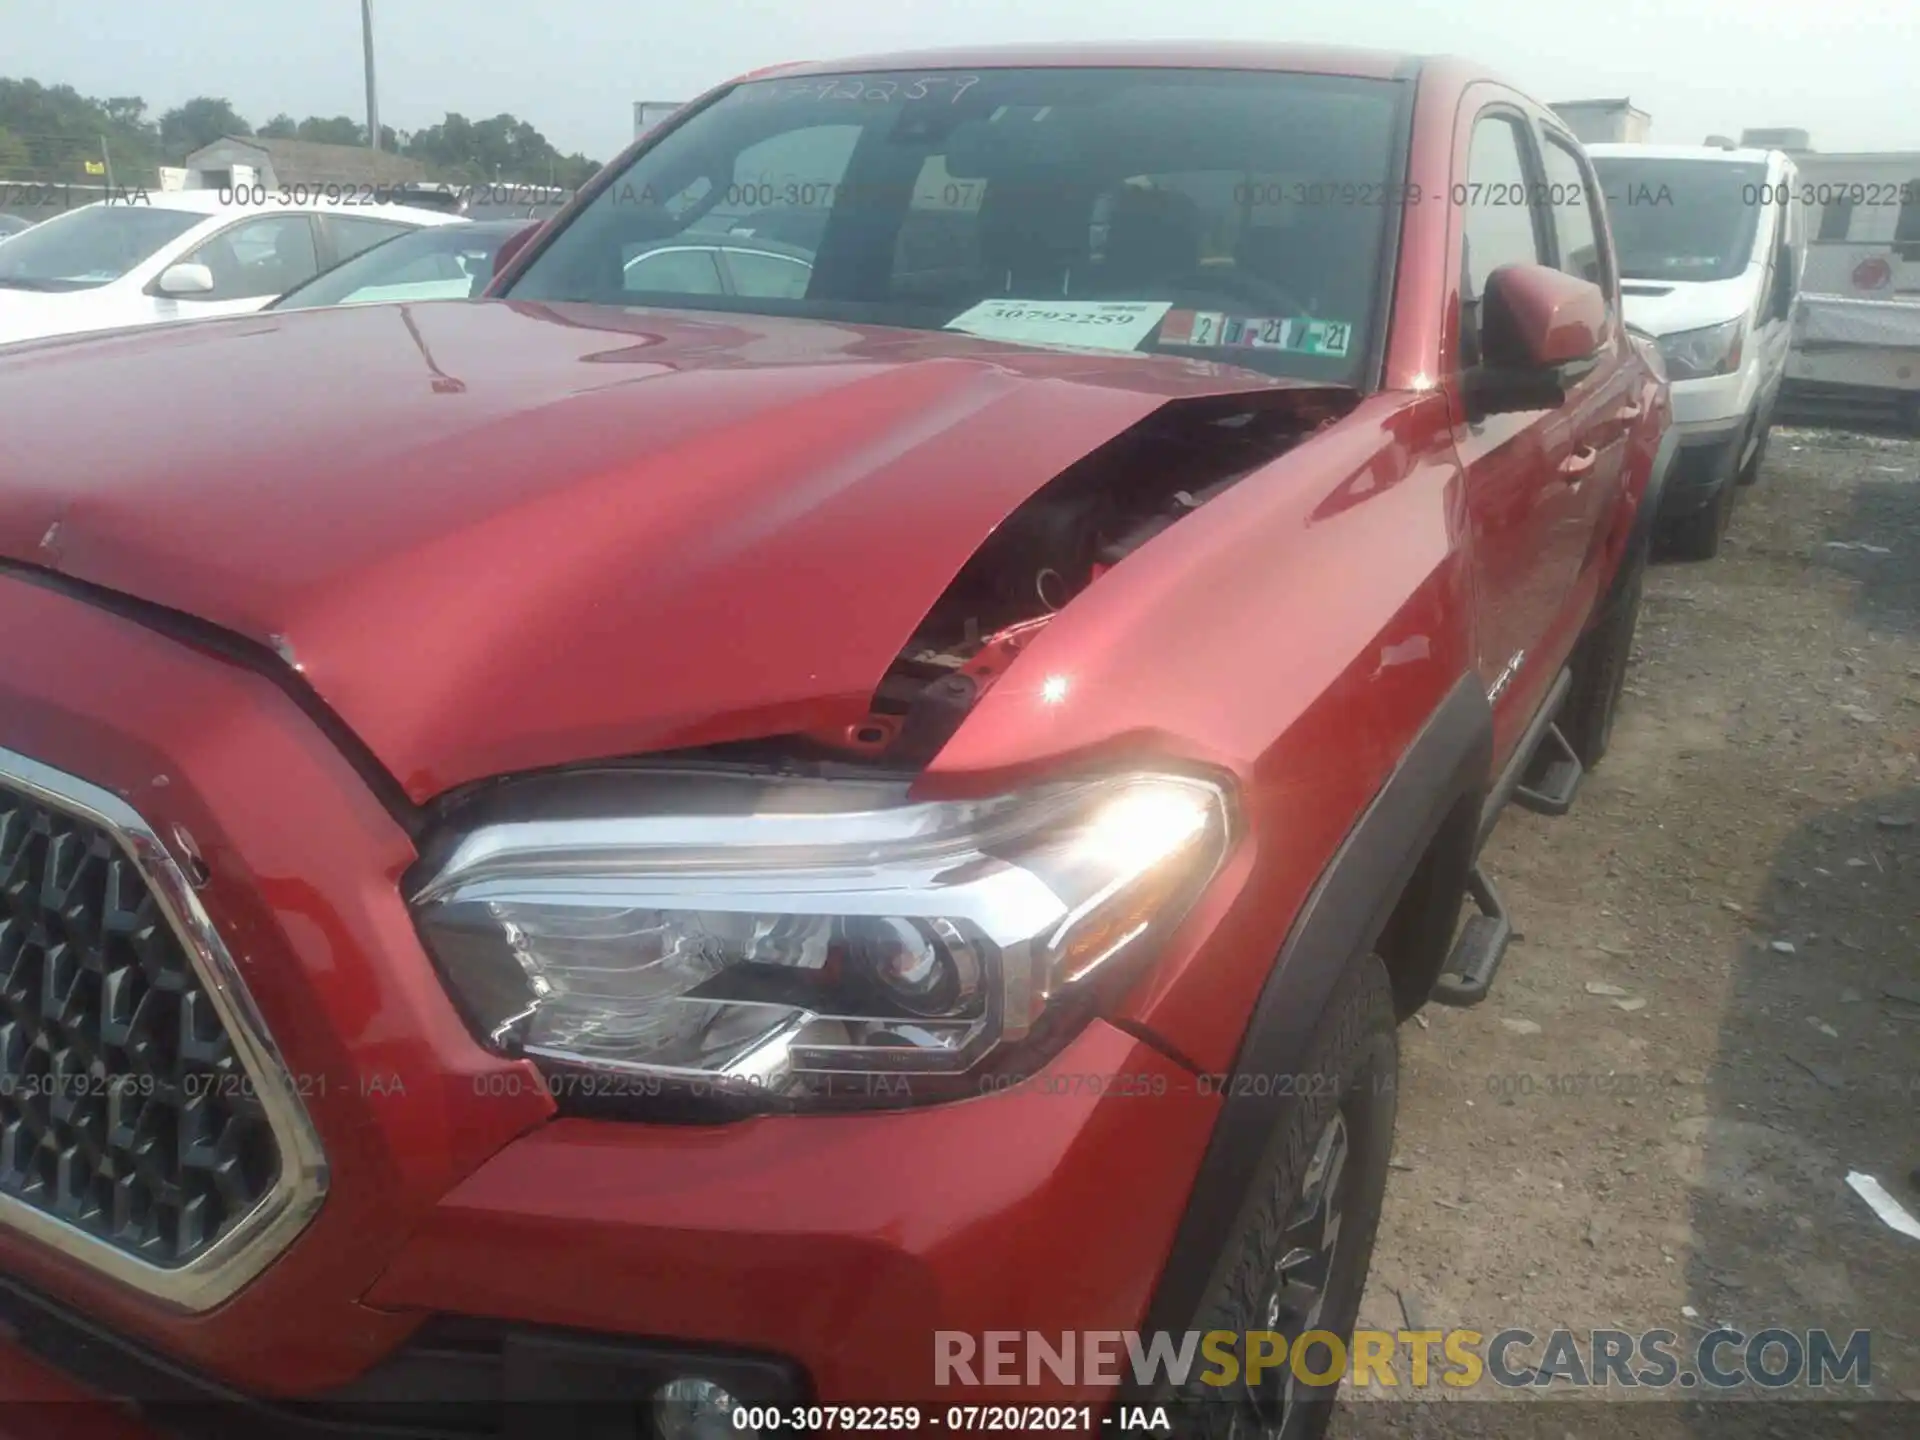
{"left": 15, "top": 0, "right": 1920, "bottom": 159}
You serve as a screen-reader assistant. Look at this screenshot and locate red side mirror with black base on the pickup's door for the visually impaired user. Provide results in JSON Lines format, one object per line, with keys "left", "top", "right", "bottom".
{"left": 1465, "top": 265, "right": 1607, "bottom": 419}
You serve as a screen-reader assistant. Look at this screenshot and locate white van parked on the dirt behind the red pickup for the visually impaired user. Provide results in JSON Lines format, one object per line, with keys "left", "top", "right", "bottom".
{"left": 1586, "top": 144, "right": 1807, "bottom": 559}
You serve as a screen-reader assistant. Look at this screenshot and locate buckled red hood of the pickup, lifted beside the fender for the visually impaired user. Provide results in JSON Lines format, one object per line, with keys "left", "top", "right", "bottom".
{"left": 0, "top": 301, "right": 1320, "bottom": 801}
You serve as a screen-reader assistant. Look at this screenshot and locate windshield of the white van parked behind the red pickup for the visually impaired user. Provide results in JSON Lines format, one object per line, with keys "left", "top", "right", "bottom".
{"left": 1594, "top": 156, "right": 1766, "bottom": 280}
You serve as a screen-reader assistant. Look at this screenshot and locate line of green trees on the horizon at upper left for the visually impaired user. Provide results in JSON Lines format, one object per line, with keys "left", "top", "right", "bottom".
{"left": 0, "top": 77, "right": 599, "bottom": 188}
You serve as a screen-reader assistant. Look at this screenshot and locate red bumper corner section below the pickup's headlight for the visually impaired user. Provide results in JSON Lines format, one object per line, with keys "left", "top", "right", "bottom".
{"left": 369, "top": 1021, "right": 1219, "bottom": 1404}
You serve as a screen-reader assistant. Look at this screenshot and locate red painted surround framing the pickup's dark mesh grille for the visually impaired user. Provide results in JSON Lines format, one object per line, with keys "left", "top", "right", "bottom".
{"left": 0, "top": 576, "right": 551, "bottom": 1390}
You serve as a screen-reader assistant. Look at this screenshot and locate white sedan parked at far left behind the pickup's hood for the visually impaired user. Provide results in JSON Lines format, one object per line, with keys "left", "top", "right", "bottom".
{"left": 0, "top": 190, "right": 465, "bottom": 346}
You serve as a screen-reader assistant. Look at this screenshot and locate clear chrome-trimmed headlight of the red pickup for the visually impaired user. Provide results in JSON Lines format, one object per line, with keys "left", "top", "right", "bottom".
{"left": 413, "top": 772, "right": 1229, "bottom": 1106}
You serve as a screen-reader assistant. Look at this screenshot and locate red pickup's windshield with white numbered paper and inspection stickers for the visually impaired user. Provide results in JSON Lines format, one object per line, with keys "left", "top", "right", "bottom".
{"left": 507, "top": 69, "right": 1402, "bottom": 384}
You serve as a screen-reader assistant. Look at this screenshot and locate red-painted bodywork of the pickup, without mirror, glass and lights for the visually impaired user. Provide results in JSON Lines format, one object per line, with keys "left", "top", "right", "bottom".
{"left": 0, "top": 48, "right": 1667, "bottom": 1402}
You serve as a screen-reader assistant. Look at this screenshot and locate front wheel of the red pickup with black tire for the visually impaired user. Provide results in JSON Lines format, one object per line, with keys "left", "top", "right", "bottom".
{"left": 1175, "top": 954, "right": 1400, "bottom": 1440}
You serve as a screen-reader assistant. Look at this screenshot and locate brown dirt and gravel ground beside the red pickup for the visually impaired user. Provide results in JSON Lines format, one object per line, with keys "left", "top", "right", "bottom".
{"left": 1334, "top": 430, "right": 1920, "bottom": 1440}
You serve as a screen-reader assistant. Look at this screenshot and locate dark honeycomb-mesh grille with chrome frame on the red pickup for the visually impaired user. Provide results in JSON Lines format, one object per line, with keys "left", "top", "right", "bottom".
{"left": 0, "top": 751, "right": 324, "bottom": 1308}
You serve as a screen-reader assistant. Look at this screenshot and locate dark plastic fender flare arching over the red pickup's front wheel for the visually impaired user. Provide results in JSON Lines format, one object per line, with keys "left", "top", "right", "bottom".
{"left": 1121, "top": 672, "right": 1494, "bottom": 1367}
